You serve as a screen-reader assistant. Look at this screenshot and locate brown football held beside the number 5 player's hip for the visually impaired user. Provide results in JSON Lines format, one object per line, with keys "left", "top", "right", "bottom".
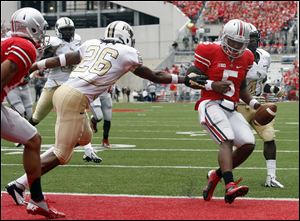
{"left": 253, "top": 103, "right": 277, "bottom": 126}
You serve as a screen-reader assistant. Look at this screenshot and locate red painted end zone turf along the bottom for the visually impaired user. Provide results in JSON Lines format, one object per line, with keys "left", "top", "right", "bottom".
{"left": 1, "top": 193, "right": 299, "bottom": 220}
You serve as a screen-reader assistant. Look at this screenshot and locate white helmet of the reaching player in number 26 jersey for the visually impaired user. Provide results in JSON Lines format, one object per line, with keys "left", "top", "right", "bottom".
{"left": 104, "top": 21, "right": 135, "bottom": 47}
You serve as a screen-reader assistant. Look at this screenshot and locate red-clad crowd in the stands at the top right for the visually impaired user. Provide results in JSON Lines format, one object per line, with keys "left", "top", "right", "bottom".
{"left": 169, "top": 1, "right": 298, "bottom": 54}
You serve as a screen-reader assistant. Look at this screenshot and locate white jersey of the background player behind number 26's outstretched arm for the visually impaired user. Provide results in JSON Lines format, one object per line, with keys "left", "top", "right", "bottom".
{"left": 45, "top": 34, "right": 81, "bottom": 88}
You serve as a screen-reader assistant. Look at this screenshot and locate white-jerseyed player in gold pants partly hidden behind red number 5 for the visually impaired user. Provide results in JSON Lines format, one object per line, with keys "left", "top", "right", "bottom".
{"left": 238, "top": 23, "right": 284, "bottom": 188}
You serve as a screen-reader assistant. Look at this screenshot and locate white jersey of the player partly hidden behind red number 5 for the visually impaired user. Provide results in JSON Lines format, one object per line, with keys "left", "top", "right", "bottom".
{"left": 246, "top": 48, "right": 271, "bottom": 96}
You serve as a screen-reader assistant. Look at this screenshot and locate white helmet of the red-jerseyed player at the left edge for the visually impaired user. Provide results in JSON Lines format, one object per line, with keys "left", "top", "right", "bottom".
{"left": 11, "top": 7, "right": 48, "bottom": 48}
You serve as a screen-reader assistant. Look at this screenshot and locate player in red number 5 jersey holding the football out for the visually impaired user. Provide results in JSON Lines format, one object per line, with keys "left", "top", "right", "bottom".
{"left": 188, "top": 19, "right": 260, "bottom": 203}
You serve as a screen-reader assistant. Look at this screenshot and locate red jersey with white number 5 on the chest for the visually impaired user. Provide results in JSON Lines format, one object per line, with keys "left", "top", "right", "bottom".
{"left": 194, "top": 42, "right": 254, "bottom": 110}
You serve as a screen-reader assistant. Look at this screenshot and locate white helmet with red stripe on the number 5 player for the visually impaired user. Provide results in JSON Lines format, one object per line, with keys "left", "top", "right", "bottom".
{"left": 221, "top": 19, "right": 249, "bottom": 58}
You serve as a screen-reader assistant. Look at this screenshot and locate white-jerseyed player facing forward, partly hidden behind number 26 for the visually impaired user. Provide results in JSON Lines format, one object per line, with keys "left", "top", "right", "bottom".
{"left": 29, "top": 17, "right": 102, "bottom": 163}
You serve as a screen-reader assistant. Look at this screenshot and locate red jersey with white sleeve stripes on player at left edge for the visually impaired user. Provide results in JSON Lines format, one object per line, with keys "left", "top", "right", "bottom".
{"left": 1, "top": 37, "right": 36, "bottom": 102}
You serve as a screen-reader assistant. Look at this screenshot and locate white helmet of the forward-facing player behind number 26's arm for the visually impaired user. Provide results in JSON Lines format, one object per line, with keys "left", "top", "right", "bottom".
{"left": 55, "top": 17, "right": 75, "bottom": 42}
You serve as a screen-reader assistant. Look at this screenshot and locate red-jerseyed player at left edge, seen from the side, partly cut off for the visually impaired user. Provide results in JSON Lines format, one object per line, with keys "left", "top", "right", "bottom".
{"left": 1, "top": 8, "right": 65, "bottom": 218}
